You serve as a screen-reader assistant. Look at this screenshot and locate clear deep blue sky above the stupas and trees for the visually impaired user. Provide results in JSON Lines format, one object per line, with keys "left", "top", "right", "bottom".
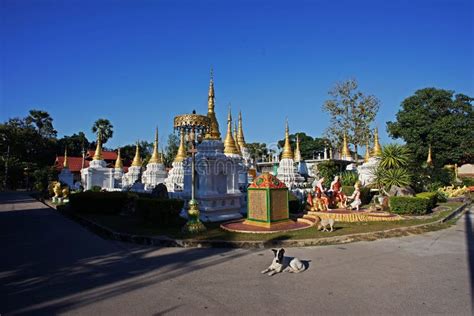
{"left": 0, "top": 0, "right": 474, "bottom": 147}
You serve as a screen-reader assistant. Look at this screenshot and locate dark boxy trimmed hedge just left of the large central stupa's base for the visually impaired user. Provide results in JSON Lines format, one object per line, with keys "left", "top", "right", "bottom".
{"left": 135, "top": 198, "right": 184, "bottom": 226}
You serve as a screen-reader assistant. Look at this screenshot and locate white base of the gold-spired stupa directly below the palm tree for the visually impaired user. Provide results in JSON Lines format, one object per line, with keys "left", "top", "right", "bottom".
{"left": 81, "top": 160, "right": 115, "bottom": 190}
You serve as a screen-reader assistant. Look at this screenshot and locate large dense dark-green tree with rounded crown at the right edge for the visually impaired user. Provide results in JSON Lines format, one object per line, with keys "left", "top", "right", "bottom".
{"left": 387, "top": 88, "right": 474, "bottom": 167}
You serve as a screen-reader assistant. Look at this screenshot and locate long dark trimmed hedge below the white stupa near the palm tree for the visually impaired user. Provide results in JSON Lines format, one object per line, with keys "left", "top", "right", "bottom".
{"left": 69, "top": 191, "right": 129, "bottom": 214}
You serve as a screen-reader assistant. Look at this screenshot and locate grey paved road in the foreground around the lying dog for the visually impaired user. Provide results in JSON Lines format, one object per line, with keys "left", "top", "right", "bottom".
{"left": 0, "top": 194, "right": 474, "bottom": 315}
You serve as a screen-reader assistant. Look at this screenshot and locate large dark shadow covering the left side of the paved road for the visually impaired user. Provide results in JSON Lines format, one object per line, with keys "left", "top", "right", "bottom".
{"left": 0, "top": 193, "right": 248, "bottom": 315}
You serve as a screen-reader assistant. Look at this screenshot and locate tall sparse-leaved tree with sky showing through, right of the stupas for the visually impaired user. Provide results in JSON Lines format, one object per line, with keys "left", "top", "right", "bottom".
{"left": 323, "top": 79, "right": 380, "bottom": 159}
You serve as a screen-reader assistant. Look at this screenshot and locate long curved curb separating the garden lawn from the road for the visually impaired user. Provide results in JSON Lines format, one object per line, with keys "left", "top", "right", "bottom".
{"left": 43, "top": 201, "right": 470, "bottom": 249}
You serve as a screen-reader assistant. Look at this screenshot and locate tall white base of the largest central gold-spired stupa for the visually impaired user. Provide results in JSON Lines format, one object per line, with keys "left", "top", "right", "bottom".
{"left": 181, "top": 140, "right": 243, "bottom": 222}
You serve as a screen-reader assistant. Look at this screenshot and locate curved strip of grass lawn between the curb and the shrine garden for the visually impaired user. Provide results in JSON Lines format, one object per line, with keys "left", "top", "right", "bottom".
{"left": 68, "top": 202, "right": 462, "bottom": 241}
